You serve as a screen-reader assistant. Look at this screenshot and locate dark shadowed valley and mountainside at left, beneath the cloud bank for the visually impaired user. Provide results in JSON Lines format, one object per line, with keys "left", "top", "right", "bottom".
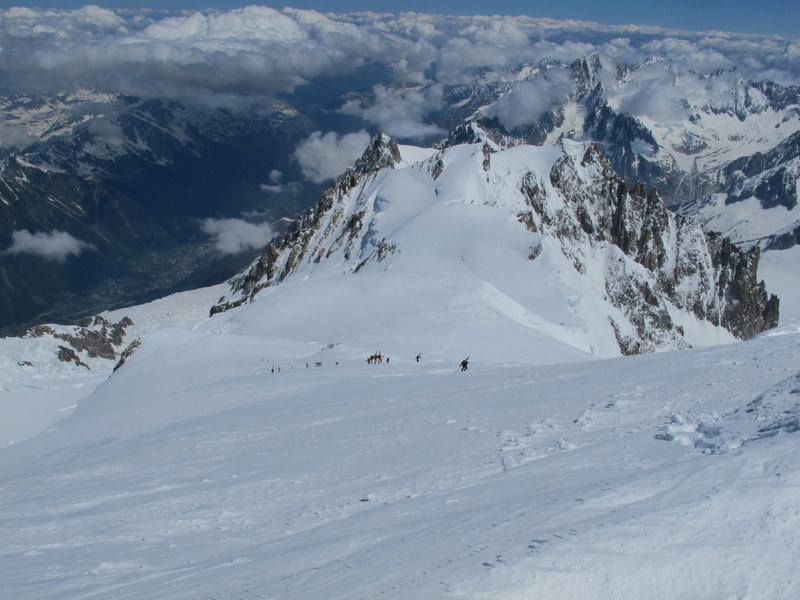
{"left": 0, "top": 94, "right": 319, "bottom": 329}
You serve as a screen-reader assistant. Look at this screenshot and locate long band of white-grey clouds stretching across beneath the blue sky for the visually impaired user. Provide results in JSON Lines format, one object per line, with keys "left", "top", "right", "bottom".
{"left": 0, "top": 6, "right": 800, "bottom": 125}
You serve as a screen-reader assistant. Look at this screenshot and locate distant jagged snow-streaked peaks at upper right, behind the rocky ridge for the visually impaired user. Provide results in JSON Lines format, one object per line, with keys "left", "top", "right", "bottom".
{"left": 432, "top": 54, "right": 800, "bottom": 248}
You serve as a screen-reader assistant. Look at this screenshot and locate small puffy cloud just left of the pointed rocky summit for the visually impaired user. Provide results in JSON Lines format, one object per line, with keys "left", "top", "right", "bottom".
{"left": 294, "top": 130, "right": 370, "bottom": 183}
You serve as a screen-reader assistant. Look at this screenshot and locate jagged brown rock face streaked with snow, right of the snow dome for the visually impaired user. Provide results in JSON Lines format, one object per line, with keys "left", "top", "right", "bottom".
{"left": 521, "top": 144, "right": 779, "bottom": 353}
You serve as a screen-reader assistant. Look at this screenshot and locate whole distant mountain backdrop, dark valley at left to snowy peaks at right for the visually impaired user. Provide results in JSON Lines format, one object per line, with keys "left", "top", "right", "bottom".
{"left": 0, "top": 54, "right": 800, "bottom": 332}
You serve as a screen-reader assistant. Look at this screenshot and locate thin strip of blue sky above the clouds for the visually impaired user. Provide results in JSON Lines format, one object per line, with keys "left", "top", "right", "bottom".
{"left": 0, "top": 0, "right": 800, "bottom": 38}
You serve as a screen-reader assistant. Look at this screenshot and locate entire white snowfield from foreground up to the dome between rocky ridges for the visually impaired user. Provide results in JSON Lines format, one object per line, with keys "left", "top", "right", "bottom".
{"left": 0, "top": 136, "right": 800, "bottom": 600}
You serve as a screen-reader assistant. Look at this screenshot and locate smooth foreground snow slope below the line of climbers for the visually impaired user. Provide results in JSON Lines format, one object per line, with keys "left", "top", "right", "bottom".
{"left": 0, "top": 303, "right": 800, "bottom": 600}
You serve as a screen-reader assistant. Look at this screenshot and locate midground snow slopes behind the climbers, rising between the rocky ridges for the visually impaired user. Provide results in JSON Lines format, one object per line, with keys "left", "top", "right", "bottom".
{"left": 0, "top": 137, "right": 776, "bottom": 445}
